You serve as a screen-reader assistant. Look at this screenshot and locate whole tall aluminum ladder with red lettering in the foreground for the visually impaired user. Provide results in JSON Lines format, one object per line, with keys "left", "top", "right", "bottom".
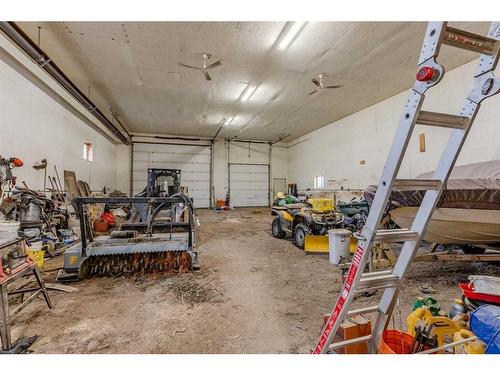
{"left": 313, "top": 22, "right": 500, "bottom": 354}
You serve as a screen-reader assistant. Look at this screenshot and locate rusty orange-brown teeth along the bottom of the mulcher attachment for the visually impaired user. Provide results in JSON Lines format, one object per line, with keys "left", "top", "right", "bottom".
{"left": 81, "top": 251, "right": 191, "bottom": 279}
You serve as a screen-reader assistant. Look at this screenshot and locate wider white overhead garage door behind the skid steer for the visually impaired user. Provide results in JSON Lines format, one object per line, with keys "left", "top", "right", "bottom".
{"left": 132, "top": 142, "right": 210, "bottom": 208}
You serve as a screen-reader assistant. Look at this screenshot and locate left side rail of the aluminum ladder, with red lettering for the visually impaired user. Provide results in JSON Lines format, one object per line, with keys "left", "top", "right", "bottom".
{"left": 313, "top": 22, "right": 446, "bottom": 354}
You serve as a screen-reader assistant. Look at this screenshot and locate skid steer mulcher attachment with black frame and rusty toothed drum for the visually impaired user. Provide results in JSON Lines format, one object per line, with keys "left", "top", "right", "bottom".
{"left": 58, "top": 197, "right": 197, "bottom": 281}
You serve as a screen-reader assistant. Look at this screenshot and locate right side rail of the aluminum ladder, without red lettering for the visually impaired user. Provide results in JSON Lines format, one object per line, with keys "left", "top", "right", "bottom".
{"left": 370, "top": 22, "right": 500, "bottom": 353}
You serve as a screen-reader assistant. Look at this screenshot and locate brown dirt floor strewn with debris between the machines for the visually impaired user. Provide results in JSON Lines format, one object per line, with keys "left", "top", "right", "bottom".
{"left": 8, "top": 209, "right": 499, "bottom": 353}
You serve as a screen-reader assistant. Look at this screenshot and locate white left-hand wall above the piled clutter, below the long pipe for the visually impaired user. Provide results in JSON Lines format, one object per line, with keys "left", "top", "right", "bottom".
{"left": 0, "top": 55, "right": 116, "bottom": 190}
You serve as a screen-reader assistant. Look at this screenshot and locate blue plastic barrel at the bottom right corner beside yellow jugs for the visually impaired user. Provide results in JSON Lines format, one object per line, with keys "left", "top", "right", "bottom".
{"left": 470, "top": 305, "right": 500, "bottom": 354}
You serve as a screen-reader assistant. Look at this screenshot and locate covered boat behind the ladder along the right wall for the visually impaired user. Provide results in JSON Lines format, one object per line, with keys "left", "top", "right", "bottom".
{"left": 365, "top": 160, "right": 500, "bottom": 245}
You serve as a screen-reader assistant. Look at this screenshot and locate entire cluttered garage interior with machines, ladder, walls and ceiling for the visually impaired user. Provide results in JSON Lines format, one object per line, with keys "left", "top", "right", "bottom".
{"left": 0, "top": 21, "right": 500, "bottom": 354}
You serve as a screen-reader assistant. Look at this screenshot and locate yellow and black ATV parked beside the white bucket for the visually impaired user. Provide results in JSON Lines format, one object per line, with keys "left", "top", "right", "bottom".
{"left": 271, "top": 198, "right": 344, "bottom": 249}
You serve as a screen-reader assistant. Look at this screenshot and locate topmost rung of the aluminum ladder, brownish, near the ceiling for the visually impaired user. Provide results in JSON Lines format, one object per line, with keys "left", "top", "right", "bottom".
{"left": 443, "top": 27, "right": 499, "bottom": 55}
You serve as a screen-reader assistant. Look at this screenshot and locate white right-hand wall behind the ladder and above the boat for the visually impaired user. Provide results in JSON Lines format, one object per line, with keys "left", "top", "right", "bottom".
{"left": 288, "top": 61, "right": 500, "bottom": 189}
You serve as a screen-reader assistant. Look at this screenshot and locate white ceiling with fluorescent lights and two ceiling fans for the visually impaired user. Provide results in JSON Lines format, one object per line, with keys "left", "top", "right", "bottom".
{"left": 14, "top": 22, "right": 489, "bottom": 140}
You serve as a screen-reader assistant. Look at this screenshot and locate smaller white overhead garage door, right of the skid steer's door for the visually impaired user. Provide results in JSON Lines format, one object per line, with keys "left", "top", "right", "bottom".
{"left": 229, "top": 164, "right": 269, "bottom": 207}
